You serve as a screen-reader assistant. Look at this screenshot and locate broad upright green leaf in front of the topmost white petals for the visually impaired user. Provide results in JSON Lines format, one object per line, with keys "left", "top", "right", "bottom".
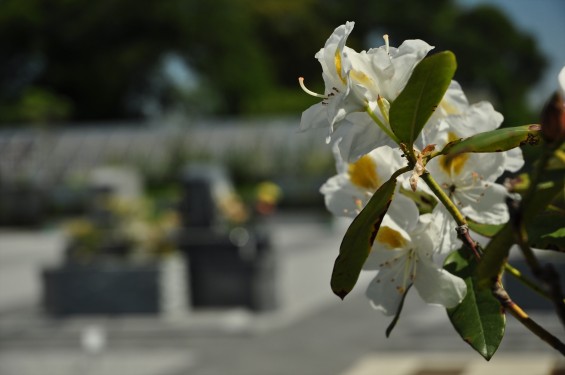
{"left": 389, "top": 51, "right": 457, "bottom": 149}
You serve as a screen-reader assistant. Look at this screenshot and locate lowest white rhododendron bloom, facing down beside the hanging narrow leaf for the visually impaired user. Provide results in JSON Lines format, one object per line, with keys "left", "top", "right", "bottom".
{"left": 363, "top": 195, "right": 467, "bottom": 315}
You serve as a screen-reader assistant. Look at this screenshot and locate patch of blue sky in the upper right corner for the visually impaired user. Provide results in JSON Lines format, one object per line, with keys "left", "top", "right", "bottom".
{"left": 458, "top": 0, "right": 565, "bottom": 106}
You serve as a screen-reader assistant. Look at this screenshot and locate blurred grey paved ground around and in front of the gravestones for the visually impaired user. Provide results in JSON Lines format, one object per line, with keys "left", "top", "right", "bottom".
{"left": 0, "top": 216, "right": 565, "bottom": 375}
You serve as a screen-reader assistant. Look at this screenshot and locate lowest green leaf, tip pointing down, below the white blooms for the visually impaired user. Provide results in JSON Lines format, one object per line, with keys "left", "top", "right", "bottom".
{"left": 444, "top": 249, "right": 506, "bottom": 361}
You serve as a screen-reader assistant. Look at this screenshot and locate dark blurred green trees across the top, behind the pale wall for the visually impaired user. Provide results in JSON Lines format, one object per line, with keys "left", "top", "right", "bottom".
{"left": 0, "top": 0, "right": 544, "bottom": 123}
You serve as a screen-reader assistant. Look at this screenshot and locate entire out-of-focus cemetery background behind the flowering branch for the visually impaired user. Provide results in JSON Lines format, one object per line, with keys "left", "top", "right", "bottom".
{"left": 0, "top": 0, "right": 565, "bottom": 375}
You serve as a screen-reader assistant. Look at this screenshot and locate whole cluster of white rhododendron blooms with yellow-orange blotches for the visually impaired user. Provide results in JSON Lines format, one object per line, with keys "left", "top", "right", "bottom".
{"left": 300, "top": 22, "right": 523, "bottom": 315}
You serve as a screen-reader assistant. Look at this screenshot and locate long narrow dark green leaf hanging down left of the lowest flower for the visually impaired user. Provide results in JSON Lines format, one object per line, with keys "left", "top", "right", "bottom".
{"left": 330, "top": 177, "right": 396, "bottom": 299}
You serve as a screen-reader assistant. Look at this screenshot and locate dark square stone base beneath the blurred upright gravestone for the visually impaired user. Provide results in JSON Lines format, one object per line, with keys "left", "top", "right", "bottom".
{"left": 179, "top": 228, "right": 278, "bottom": 311}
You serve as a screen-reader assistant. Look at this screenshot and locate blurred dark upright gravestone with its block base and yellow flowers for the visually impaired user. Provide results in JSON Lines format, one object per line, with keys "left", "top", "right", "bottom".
{"left": 175, "top": 165, "right": 277, "bottom": 310}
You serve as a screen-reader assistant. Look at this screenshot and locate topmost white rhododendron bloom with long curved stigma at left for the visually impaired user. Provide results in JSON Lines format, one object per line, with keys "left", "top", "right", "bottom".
{"left": 300, "top": 22, "right": 433, "bottom": 162}
